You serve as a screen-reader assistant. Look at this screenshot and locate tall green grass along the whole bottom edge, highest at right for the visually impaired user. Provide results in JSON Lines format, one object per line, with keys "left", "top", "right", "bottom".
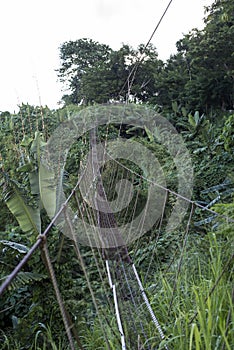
{"left": 0, "top": 212, "right": 234, "bottom": 350}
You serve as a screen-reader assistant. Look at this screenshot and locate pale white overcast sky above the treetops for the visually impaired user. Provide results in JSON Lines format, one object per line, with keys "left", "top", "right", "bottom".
{"left": 0, "top": 0, "right": 213, "bottom": 112}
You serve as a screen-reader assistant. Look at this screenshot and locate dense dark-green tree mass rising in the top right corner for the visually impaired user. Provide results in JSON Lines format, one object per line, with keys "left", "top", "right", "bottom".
{"left": 156, "top": 0, "right": 234, "bottom": 113}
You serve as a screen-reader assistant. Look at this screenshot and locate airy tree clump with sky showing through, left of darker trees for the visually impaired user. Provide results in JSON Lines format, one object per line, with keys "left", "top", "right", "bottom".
{"left": 58, "top": 39, "right": 162, "bottom": 104}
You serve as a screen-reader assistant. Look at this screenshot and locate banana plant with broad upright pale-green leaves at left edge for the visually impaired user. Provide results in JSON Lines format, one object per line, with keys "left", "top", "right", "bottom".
{"left": 0, "top": 131, "right": 64, "bottom": 260}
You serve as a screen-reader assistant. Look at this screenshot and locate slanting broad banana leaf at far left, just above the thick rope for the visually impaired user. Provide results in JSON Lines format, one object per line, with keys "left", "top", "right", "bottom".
{"left": 5, "top": 183, "right": 41, "bottom": 235}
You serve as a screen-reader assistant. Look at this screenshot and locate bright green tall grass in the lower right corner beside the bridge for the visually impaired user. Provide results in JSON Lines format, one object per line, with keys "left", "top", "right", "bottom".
{"left": 146, "top": 233, "right": 234, "bottom": 350}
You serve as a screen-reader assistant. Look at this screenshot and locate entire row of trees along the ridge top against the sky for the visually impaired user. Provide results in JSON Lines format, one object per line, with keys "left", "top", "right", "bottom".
{"left": 58, "top": 0, "right": 234, "bottom": 114}
